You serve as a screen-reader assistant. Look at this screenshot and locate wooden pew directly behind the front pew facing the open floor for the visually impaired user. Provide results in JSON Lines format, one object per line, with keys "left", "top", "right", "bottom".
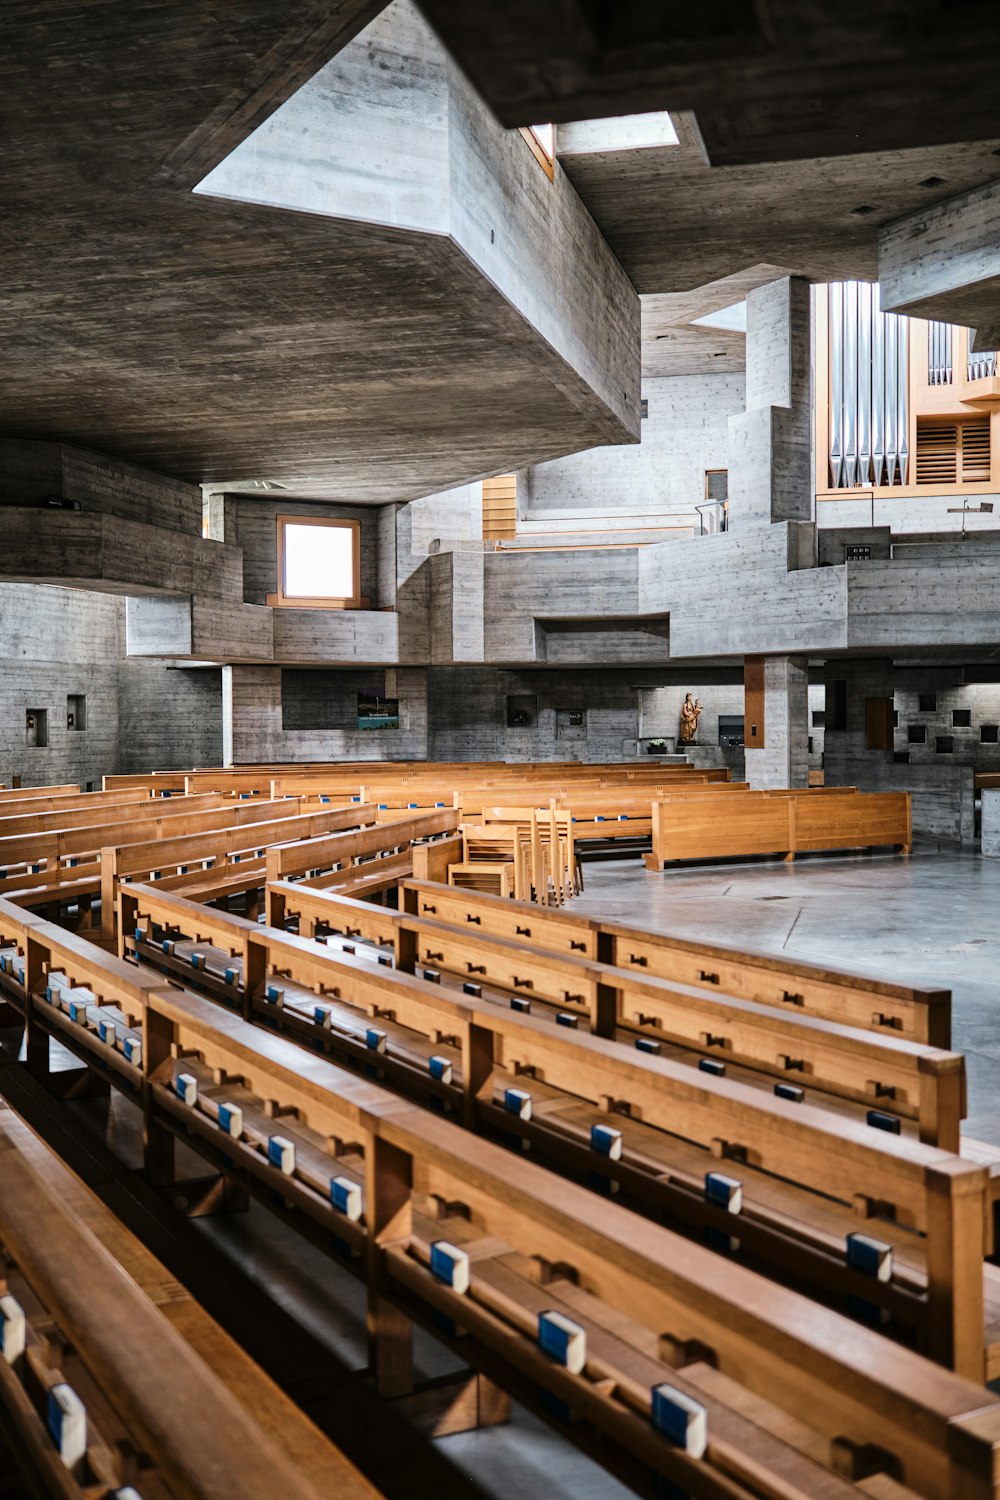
{"left": 268, "top": 882, "right": 966, "bottom": 1151}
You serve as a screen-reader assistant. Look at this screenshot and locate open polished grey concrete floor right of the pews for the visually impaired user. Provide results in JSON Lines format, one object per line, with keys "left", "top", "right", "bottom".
{"left": 571, "top": 843, "right": 1000, "bottom": 1145}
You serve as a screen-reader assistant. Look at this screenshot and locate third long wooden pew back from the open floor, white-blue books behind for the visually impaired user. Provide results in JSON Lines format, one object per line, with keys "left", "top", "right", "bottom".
{"left": 103, "top": 887, "right": 1000, "bottom": 1377}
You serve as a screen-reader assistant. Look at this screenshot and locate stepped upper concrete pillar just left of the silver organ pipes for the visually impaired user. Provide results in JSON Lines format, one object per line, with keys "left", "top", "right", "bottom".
{"left": 729, "top": 276, "right": 813, "bottom": 530}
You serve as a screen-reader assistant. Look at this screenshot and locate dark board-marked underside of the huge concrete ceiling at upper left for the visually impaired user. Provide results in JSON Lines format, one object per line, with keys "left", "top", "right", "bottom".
{"left": 0, "top": 0, "right": 637, "bottom": 504}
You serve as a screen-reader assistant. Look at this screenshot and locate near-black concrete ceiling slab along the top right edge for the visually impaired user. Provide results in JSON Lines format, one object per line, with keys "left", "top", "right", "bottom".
{"left": 420, "top": 0, "right": 1000, "bottom": 165}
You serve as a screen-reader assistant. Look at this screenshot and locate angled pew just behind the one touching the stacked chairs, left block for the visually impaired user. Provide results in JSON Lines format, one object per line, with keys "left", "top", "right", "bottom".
{"left": 100, "top": 800, "right": 375, "bottom": 939}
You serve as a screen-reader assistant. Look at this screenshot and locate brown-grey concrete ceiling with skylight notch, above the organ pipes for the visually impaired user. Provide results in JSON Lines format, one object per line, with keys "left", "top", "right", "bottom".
{"left": 559, "top": 117, "right": 1000, "bottom": 300}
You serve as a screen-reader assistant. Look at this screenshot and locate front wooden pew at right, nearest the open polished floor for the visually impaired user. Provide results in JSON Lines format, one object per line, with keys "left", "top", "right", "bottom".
{"left": 401, "top": 879, "right": 952, "bottom": 1050}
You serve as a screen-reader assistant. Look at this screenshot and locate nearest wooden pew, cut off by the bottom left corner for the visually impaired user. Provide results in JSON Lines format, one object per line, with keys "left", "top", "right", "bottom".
{"left": 0, "top": 1104, "right": 378, "bottom": 1500}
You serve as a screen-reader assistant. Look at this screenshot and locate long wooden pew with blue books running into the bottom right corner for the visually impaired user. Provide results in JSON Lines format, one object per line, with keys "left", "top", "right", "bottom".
{"left": 4, "top": 903, "right": 1000, "bottom": 1500}
